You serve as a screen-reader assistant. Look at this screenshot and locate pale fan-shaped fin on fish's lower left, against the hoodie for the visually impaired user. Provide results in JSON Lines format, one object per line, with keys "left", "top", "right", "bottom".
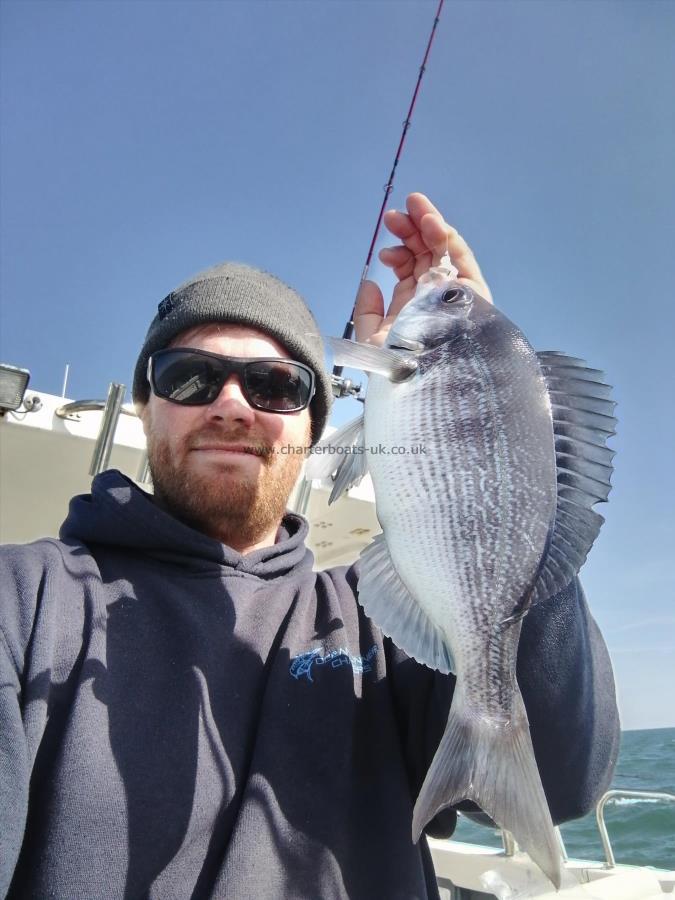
{"left": 358, "top": 534, "right": 453, "bottom": 675}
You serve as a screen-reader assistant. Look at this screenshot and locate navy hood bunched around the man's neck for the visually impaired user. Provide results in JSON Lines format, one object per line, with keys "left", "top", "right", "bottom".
{"left": 59, "top": 469, "right": 314, "bottom": 579}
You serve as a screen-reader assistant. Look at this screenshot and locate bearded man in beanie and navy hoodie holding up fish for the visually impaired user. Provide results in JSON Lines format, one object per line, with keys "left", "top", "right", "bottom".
{"left": 0, "top": 194, "right": 618, "bottom": 900}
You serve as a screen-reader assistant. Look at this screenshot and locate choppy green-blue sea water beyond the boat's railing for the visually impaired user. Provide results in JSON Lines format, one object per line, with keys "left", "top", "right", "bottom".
{"left": 453, "top": 728, "right": 675, "bottom": 869}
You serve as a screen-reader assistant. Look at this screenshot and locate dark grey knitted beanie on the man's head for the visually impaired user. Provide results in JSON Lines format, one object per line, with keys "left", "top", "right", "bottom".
{"left": 133, "top": 262, "right": 333, "bottom": 444}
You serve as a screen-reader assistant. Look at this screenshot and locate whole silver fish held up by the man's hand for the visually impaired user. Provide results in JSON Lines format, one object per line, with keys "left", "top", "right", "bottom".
{"left": 307, "top": 261, "right": 616, "bottom": 888}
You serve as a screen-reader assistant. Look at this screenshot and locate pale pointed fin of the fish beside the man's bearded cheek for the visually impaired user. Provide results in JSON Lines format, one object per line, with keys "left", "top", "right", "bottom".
{"left": 305, "top": 414, "right": 368, "bottom": 504}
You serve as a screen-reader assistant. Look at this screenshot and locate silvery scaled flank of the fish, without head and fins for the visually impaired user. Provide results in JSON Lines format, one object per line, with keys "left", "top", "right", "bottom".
{"left": 365, "top": 333, "right": 555, "bottom": 713}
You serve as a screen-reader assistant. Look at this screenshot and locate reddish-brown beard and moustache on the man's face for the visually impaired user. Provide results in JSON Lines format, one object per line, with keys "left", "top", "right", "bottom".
{"left": 148, "top": 428, "right": 309, "bottom": 549}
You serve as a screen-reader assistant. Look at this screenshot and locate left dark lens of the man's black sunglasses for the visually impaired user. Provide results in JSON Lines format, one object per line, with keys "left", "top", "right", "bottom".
{"left": 152, "top": 350, "right": 223, "bottom": 406}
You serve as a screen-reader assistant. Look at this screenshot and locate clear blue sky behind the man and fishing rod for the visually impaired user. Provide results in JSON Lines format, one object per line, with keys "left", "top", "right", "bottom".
{"left": 0, "top": 0, "right": 675, "bottom": 728}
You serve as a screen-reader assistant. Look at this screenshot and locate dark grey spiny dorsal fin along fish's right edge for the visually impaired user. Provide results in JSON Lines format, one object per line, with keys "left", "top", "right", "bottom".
{"left": 531, "top": 350, "right": 616, "bottom": 603}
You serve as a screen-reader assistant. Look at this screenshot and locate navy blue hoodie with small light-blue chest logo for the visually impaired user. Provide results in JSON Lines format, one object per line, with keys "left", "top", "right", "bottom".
{"left": 0, "top": 472, "right": 618, "bottom": 900}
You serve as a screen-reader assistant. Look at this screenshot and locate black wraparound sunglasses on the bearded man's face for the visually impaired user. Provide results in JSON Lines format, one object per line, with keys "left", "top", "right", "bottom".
{"left": 148, "top": 347, "right": 314, "bottom": 413}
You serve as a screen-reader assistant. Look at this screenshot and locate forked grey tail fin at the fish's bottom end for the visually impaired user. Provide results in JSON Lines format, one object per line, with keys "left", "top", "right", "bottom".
{"left": 413, "top": 693, "right": 561, "bottom": 889}
